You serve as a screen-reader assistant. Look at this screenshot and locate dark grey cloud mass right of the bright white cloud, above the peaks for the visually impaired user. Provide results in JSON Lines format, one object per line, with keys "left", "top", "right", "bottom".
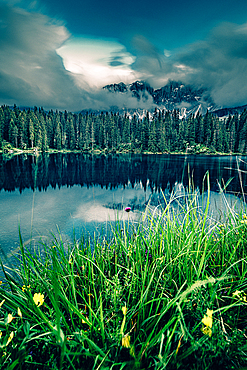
{"left": 132, "top": 23, "right": 247, "bottom": 106}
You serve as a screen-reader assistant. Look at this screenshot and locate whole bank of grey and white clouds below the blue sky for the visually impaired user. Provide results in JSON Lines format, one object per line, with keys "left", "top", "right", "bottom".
{"left": 0, "top": 0, "right": 247, "bottom": 111}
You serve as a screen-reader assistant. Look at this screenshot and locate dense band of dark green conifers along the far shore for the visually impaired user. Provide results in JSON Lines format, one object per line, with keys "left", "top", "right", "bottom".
{"left": 0, "top": 105, "right": 247, "bottom": 154}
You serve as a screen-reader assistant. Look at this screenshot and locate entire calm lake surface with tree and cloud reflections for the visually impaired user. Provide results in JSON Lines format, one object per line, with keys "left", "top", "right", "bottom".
{"left": 0, "top": 153, "right": 247, "bottom": 263}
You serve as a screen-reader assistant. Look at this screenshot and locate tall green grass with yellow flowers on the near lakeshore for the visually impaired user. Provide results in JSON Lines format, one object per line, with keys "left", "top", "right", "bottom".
{"left": 0, "top": 183, "right": 247, "bottom": 370}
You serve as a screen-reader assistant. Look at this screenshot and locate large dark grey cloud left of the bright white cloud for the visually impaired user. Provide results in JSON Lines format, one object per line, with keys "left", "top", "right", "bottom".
{"left": 0, "top": 3, "right": 93, "bottom": 110}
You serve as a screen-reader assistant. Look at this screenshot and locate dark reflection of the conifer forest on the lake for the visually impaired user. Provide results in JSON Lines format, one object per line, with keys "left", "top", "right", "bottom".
{"left": 0, "top": 153, "right": 247, "bottom": 192}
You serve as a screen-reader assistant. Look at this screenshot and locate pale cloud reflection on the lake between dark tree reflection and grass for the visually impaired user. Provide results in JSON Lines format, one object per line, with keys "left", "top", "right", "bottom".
{"left": 0, "top": 185, "right": 151, "bottom": 261}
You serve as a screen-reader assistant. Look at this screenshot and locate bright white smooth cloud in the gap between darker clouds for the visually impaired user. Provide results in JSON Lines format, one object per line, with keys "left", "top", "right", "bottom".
{"left": 57, "top": 37, "right": 135, "bottom": 87}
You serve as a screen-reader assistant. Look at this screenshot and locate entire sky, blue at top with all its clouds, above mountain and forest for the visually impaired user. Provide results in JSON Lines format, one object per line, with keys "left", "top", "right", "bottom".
{"left": 0, "top": 0, "right": 247, "bottom": 112}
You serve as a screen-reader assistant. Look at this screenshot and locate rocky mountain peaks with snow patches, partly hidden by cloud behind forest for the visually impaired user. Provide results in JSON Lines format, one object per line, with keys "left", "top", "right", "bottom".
{"left": 103, "top": 81, "right": 247, "bottom": 118}
